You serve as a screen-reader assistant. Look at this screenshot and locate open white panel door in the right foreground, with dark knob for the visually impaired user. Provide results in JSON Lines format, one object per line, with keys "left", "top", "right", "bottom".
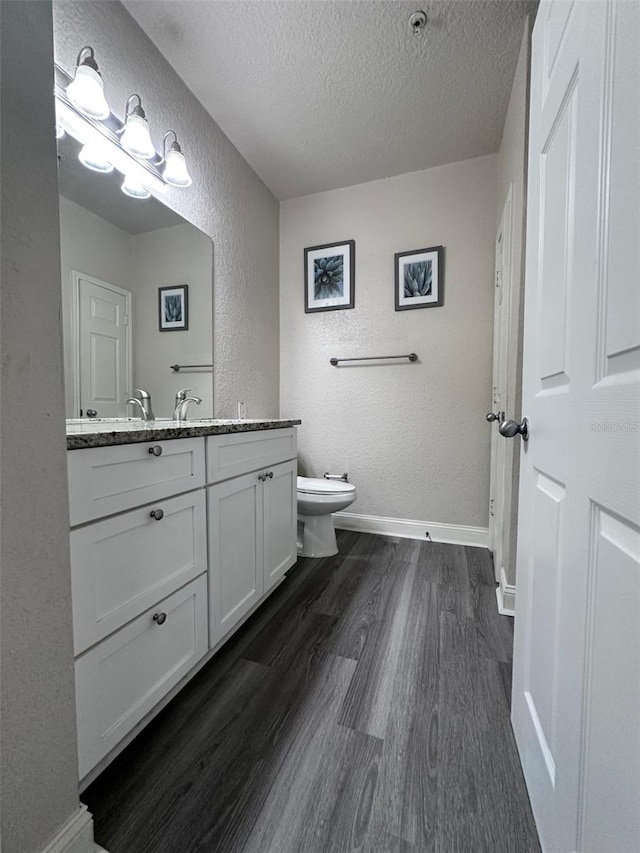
{"left": 512, "top": 0, "right": 640, "bottom": 853}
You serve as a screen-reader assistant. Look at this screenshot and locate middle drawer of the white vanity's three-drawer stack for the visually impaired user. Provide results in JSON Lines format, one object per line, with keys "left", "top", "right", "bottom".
{"left": 71, "top": 489, "right": 207, "bottom": 655}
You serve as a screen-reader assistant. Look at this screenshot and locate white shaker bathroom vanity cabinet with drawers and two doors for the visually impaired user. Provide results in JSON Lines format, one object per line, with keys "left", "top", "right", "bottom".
{"left": 68, "top": 422, "right": 297, "bottom": 782}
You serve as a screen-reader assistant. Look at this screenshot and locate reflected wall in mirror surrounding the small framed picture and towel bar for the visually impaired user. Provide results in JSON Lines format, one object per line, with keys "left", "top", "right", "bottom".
{"left": 133, "top": 224, "right": 213, "bottom": 418}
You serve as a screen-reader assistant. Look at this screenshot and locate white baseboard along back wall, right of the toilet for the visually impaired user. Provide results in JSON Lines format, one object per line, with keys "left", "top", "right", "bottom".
{"left": 333, "top": 512, "right": 489, "bottom": 548}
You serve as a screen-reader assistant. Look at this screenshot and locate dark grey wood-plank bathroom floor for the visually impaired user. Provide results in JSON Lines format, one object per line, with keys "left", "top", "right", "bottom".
{"left": 82, "top": 531, "right": 540, "bottom": 853}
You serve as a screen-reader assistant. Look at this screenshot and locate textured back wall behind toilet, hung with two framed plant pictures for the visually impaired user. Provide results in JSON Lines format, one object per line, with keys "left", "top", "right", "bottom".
{"left": 280, "top": 155, "right": 496, "bottom": 526}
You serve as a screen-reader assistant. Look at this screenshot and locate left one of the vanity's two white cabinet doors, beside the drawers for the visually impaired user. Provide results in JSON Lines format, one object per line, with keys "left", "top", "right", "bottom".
{"left": 208, "top": 472, "right": 264, "bottom": 647}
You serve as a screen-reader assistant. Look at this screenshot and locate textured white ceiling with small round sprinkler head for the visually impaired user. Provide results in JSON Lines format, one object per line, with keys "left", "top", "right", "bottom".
{"left": 124, "top": 0, "right": 537, "bottom": 199}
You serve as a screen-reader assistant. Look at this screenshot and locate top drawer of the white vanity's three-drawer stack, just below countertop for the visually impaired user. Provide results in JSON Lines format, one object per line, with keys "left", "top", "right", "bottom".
{"left": 67, "top": 438, "right": 204, "bottom": 526}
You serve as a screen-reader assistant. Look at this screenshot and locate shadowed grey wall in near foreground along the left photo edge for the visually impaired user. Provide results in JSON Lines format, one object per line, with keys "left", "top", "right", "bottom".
{"left": 0, "top": 2, "right": 85, "bottom": 853}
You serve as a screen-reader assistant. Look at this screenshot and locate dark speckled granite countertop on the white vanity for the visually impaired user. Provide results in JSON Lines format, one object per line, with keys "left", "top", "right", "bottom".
{"left": 67, "top": 418, "right": 302, "bottom": 450}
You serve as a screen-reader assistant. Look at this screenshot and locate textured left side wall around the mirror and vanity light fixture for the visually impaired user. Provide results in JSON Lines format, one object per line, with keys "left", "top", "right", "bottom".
{"left": 54, "top": 0, "right": 278, "bottom": 417}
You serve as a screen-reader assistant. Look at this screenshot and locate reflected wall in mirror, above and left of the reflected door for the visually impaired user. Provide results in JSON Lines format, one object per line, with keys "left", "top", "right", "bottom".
{"left": 60, "top": 196, "right": 134, "bottom": 418}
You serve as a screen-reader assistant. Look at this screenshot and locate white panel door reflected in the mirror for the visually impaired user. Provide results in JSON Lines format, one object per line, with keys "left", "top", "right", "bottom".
{"left": 73, "top": 270, "right": 132, "bottom": 418}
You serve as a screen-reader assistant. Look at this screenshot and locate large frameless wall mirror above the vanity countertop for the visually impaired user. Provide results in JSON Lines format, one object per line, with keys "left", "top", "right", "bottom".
{"left": 58, "top": 135, "right": 213, "bottom": 418}
